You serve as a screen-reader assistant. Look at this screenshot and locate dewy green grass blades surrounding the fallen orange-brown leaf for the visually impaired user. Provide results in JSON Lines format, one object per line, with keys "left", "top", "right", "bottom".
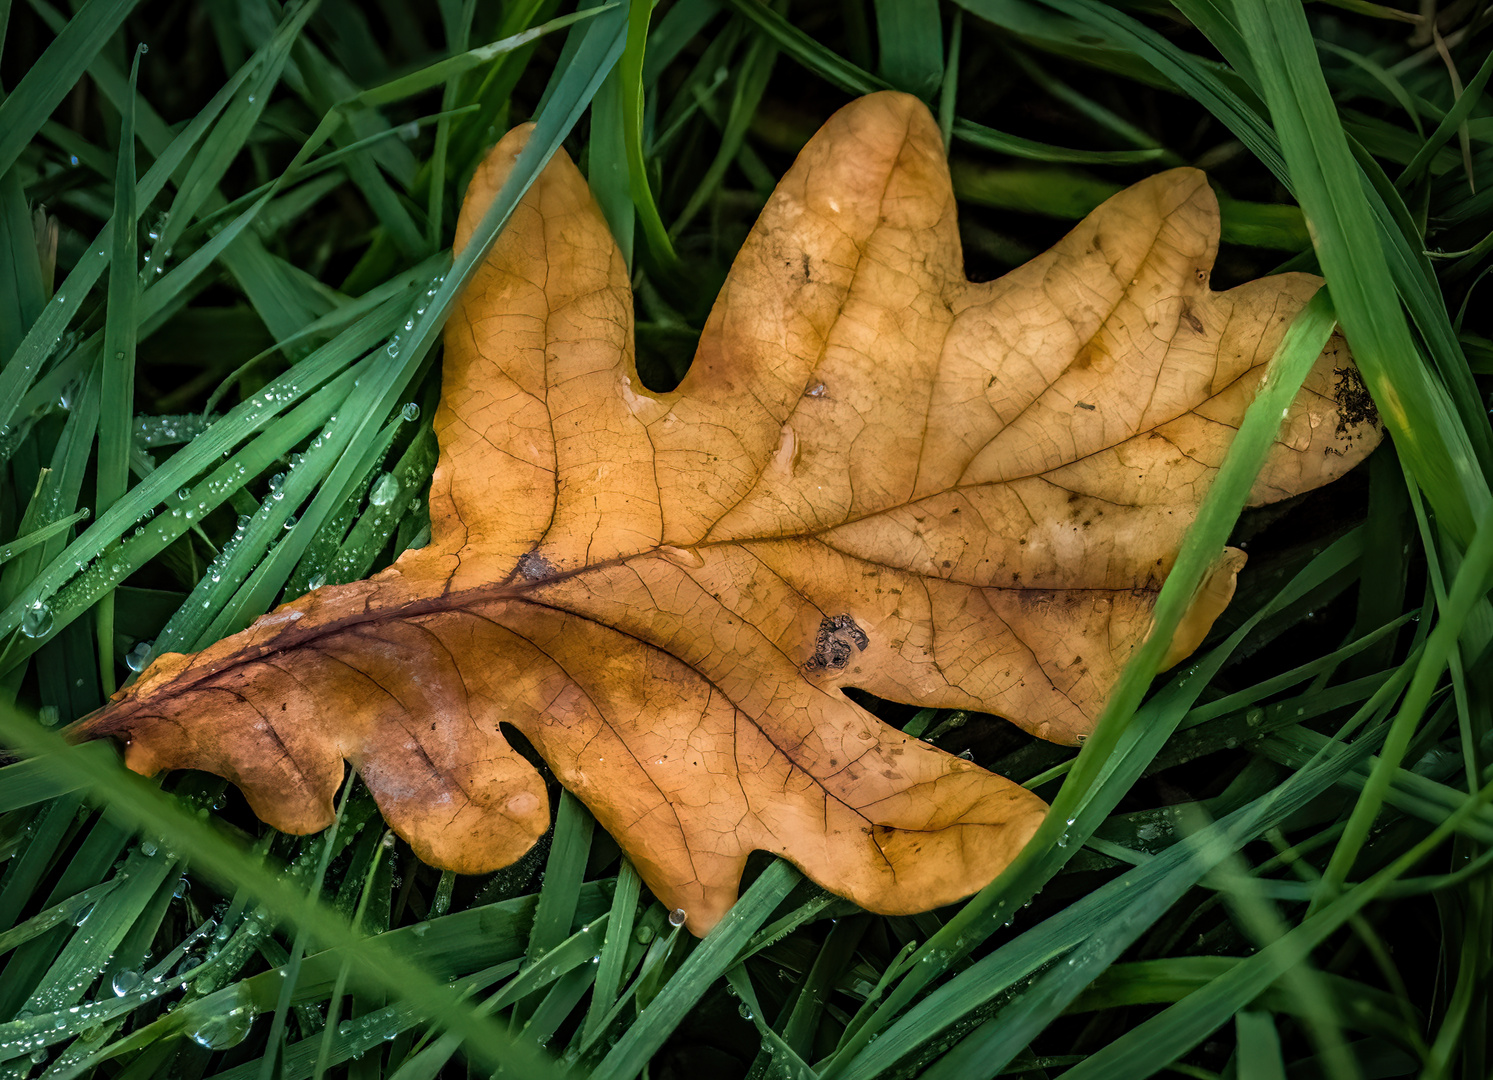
{"left": 0, "top": 0, "right": 1493, "bottom": 1080}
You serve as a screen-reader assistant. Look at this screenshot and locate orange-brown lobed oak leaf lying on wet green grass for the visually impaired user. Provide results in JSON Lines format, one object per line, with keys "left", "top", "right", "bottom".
{"left": 82, "top": 93, "right": 1378, "bottom": 934}
